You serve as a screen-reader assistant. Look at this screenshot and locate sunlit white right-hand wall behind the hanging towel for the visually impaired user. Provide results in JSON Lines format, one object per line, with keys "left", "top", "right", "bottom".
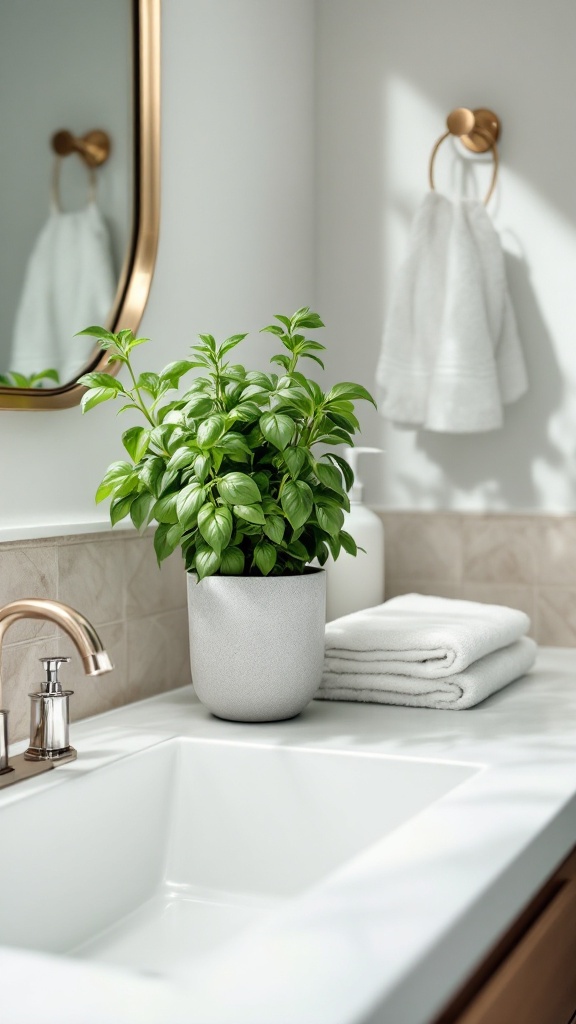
{"left": 317, "top": 0, "right": 576, "bottom": 511}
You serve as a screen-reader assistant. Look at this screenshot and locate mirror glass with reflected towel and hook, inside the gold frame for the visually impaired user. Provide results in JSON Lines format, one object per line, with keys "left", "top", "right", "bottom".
{"left": 0, "top": 0, "right": 134, "bottom": 389}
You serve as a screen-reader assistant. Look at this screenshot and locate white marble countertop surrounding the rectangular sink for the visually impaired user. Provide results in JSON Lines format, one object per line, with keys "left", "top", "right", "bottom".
{"left": 0, "top": 648, "right": 576, "bottom": 1024}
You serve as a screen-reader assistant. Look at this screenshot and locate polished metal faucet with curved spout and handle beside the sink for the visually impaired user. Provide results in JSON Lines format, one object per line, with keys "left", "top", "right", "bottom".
{"left": 0, "top": 597, "right": 113, "bottom": 785}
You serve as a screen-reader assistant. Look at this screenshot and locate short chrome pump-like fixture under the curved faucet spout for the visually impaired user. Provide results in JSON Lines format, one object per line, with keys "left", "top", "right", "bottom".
{"left": 24, "top": 657, "right": 76, "bottom": 761}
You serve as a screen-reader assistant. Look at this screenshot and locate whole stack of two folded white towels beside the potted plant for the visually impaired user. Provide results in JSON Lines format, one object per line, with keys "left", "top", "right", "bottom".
{"left": 316, "top": 594, "right": 536, "bottom": 710}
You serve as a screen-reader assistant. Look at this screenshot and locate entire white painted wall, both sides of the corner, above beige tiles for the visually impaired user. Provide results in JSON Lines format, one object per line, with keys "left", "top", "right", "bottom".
{"left": 0, "top": 0, "right": 576, "bottom": 538}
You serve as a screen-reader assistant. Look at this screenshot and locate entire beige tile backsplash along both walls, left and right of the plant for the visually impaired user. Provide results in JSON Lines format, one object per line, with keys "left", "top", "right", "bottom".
{"left": 0, "top": 512, "right": 576, "bottom": 739}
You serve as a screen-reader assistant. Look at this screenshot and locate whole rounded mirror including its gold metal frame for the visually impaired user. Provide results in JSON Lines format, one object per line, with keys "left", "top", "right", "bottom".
{"left": 0, "top": 0, "right": 161, "bottom": 411}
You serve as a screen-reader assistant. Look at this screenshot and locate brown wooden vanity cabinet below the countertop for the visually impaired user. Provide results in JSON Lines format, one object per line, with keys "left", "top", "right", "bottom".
{"left": 434, "top": 849, "right": 576, "bottom": 1024}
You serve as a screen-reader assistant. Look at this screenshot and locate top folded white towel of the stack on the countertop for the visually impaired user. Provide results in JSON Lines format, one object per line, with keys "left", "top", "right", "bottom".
{"left": 325, "top": 594, "right": 530, "bottom": 679}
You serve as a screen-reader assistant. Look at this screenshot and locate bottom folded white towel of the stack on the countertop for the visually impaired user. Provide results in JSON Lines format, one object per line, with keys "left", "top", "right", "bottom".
{"left": 316, "top": 637, "right": 537, "bottom": 711}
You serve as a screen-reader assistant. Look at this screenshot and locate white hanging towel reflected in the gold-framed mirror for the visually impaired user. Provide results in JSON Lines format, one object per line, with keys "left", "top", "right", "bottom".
{"left": 9, "top": 202, "right": 116, "bottom": 384}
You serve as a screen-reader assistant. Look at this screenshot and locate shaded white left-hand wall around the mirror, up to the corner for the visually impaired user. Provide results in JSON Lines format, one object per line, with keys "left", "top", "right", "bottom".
{"left": 0, "top": 0, "right": 314, "bottom": 539}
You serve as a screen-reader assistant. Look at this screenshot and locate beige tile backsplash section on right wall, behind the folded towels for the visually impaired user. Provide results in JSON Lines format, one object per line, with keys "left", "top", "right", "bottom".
{"left": 379, "top": 512, "right": 576, "bottom": 647}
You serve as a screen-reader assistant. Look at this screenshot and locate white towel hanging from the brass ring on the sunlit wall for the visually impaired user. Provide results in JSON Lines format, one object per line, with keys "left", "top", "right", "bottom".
{"left": 376, "top": 191, "right": 528, "bottom": 433}
